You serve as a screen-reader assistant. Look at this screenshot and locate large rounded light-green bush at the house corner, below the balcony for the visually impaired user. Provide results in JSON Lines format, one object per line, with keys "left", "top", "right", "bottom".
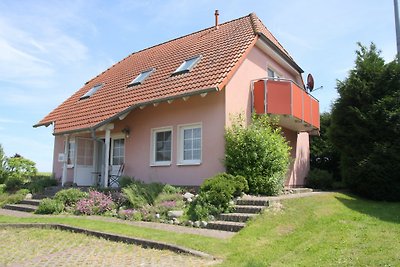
{"left": 224, "top": 115, "right": 290, "bottom": 195}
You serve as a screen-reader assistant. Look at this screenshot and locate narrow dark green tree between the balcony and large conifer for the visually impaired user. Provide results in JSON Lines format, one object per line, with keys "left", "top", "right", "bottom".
{"left": 310, "top": 112, "right": 341, "bottom": 181}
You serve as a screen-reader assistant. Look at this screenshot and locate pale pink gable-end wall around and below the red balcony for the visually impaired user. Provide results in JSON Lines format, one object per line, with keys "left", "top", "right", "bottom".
{"left": 225, "top": 46, "right": 310, "bottom": 187}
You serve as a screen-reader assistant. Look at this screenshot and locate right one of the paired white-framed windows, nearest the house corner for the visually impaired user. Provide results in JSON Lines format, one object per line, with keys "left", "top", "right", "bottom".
{"left": 179, "top": 124, "right": 202, "bottom": 164}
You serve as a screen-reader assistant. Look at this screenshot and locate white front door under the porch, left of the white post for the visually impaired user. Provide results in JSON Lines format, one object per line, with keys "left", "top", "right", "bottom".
{"left": 74, "top": 137, "right": 95, "bottom": 186}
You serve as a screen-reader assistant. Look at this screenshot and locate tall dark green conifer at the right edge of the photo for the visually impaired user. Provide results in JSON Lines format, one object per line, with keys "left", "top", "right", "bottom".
{"left": 329, "top": 44, "right": 400, "bottom": 201}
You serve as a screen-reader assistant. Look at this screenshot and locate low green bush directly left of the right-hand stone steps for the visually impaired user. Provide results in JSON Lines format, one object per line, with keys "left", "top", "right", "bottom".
{"left": 188, "top": 173, "right": 248, "bottom": 220}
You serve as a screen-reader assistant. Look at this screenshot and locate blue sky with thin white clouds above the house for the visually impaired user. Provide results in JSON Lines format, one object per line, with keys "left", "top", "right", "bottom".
{"left": 0, "top": 0, "right": 396, "bottom": 172}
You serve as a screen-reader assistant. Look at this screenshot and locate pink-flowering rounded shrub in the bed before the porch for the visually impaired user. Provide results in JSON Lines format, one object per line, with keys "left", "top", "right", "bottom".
{"left": 76, "top": 191, "right": 115, "bottom": 215}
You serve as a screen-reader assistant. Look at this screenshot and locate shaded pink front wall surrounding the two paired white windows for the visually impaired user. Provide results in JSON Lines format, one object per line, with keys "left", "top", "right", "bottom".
{"left": 111, "top": 91, "right": 225, "bottom": 185}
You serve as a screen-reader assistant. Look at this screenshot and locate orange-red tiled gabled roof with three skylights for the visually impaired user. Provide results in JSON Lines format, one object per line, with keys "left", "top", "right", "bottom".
{"left": 34, "top": 13, "right": 301, "bottom": 134}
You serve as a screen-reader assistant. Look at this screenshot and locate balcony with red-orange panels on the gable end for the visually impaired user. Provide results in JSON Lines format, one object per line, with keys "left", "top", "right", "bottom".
{"left": 251, "top": 79, "right": 320, "bottom": 134}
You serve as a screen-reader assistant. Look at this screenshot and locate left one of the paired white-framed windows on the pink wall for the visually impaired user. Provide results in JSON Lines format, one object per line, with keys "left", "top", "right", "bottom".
{"left": 151, "top": 127, "right": 172, "bottom": 165}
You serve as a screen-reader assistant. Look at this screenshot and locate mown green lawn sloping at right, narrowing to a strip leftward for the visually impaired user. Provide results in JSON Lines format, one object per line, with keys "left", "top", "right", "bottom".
{"left": 0, "top": 193, "right": 400, "bottom": 266}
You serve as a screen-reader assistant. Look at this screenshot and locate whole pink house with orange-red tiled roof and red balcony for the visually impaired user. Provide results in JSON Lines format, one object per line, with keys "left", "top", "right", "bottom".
{"left": 34, "top": 13, "right": 319, "bottom": 187}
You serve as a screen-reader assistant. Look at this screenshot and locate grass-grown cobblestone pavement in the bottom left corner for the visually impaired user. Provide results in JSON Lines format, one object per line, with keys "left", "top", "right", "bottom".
{"left": 0, "top": 228, "right": 217, "bottom": 266}
